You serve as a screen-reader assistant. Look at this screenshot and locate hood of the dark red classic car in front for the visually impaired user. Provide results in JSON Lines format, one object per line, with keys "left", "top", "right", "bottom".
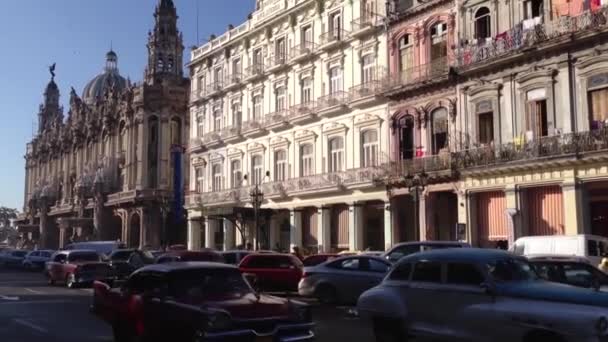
{"left": 202, "top": 293, "right": 289, "bottom": 320}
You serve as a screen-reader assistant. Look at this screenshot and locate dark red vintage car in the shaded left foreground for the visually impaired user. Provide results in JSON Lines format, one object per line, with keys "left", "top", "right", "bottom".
{"left": 91, "top": 262, "right": 314, "bottom": 342}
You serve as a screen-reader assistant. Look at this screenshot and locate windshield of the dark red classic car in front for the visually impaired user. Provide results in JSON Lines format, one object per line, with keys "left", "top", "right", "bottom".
{"left": 169, "top": 269, "right": 253, "bottom": 300}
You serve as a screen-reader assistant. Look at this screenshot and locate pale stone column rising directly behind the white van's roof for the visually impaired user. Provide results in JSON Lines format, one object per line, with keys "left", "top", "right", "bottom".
{"left": 562, "top": 178, "right": 585, "bottom": 235}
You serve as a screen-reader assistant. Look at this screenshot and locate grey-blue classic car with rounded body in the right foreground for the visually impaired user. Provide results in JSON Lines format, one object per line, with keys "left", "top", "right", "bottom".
{"left": 357, "top": 248, "right": 608, "bottom": 342}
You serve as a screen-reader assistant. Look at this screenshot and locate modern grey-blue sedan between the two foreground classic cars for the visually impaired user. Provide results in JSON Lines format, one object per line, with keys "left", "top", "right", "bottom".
{"left": 298, "top": 255, "right": 391, "bottom": 304}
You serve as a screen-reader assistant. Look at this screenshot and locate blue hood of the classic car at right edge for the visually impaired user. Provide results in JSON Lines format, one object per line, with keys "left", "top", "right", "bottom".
{"left": 496, "top": 281, "right": 608, "bottom": 308}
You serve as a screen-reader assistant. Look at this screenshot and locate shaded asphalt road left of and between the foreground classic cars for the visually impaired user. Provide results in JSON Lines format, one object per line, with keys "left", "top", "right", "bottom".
{"left": 0, "top": 269, "right": 374, "bottom": 342}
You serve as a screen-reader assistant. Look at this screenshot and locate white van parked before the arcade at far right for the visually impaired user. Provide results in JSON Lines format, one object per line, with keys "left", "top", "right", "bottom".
{"left": 509, "top": 235, "right": 608, "bottom": 266}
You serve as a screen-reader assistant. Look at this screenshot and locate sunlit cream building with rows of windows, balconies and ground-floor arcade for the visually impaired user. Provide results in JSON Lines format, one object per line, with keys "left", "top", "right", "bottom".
{"left": 186, "top": 0, "right": 392, "bottom": 252}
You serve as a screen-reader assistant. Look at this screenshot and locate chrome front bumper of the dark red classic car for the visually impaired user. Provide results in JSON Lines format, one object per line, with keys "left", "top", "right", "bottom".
{"left": 201, "top": 323, "right": 315, "bottom": 342}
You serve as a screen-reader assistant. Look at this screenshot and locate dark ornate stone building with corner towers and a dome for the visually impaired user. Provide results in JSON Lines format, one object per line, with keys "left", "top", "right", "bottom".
{"left": 18, "top": 0, "right": 189, "bottom": 248}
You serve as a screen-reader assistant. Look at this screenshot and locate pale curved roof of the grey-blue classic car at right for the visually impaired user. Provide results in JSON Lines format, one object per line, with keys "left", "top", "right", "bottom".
{"left": 400, "top": 248, "right": 525, "bottom": 263}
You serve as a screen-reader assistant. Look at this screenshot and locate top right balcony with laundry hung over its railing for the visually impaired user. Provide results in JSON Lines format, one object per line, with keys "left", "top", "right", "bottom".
{"left": 457, "top": 6, "right": 608, "bottom": 71}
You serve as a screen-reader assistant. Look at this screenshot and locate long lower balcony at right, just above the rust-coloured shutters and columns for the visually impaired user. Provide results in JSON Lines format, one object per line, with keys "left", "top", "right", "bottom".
{"left": 453, "top": 128, "right": 608, "bottom": 170}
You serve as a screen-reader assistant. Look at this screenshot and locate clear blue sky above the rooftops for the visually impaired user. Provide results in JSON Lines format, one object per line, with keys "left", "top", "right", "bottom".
{"left": 0, "top": 0, "right": 255, "bottom": 210}
